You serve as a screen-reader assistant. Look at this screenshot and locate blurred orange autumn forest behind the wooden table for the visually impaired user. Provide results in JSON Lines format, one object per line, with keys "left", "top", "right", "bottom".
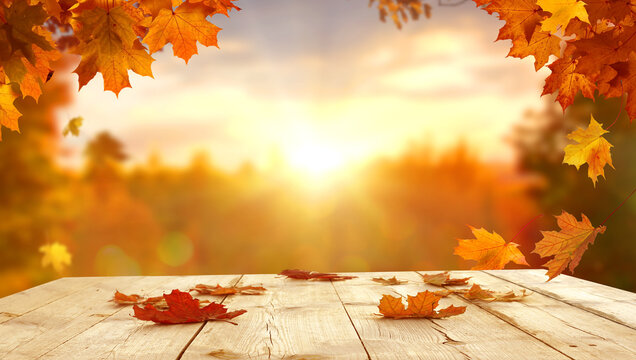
{"left": 0, "top": 75, "right": 636, "bottom": 296}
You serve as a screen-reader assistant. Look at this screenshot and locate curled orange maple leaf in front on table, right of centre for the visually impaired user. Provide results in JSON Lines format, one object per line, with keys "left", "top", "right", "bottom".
{"left": 378, "top": 291, "right": 466, "bottom": 319}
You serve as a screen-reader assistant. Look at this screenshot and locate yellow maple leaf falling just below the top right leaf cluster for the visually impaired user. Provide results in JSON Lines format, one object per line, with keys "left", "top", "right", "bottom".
{"left": 563, "top": 116, "right": 614, "bottom": 186}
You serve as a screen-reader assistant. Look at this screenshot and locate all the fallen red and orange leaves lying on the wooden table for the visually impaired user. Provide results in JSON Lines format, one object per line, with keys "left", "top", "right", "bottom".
{"left": 112, "top": 269, "right": 530, "bottom": 325}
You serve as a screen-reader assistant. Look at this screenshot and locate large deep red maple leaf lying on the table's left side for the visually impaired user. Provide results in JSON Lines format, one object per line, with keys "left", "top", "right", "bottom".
{"left": 133, "top": 289, "right": 247, "bottom": 325}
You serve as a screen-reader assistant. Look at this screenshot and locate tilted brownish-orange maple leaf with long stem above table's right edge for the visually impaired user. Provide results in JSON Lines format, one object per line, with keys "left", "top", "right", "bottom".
{"left": 532, "top": 211, "right": 606, "bottom": 281}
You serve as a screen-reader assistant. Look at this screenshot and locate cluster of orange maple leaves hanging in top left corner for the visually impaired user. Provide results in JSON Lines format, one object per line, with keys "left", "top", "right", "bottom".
{"left": 0, "top": 0, "right": 240, "bottom": 140}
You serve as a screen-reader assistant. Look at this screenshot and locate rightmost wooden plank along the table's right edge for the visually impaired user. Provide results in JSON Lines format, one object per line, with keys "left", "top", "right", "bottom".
{"left": 486, "top": 270, "right": 636, "bottom": 330}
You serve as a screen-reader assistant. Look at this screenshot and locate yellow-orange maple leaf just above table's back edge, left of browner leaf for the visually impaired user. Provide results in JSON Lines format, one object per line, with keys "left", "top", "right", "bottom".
{"left": 455, "top": 226, "right": 529, "bottom": 270}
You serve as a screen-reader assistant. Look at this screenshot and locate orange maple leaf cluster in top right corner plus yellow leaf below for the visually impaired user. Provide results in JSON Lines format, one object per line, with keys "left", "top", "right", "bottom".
{"left": 473, "top": 0, "right": 636, "bottom": 185}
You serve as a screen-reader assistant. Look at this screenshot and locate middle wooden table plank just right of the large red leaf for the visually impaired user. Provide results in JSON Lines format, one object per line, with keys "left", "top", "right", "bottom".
{"left": 183, "top": 275, "right": 367, "bottom": 359}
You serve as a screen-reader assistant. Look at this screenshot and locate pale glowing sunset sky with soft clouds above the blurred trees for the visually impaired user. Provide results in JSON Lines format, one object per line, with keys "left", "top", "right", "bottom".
{"left": 59, "top": 0, "right": 549, "bottom": 172}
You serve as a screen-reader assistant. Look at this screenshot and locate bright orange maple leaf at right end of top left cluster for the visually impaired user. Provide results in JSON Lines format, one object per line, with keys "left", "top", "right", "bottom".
{"left": 143, "top": 2, "right": 221, "bottom": 64}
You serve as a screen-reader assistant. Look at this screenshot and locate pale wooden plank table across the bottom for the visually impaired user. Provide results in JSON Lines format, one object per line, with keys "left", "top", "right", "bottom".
{"left": 0, "top": 270, "right": 636, "bottom": 360}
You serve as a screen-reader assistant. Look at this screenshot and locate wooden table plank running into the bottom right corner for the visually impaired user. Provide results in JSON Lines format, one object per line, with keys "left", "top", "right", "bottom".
{"left": 447, "top": 271, "right": 636, "bottom": 360}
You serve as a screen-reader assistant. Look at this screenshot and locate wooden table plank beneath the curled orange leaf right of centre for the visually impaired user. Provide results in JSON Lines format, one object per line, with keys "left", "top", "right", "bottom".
{"left": 334, "top": 272, "right": 567, "bottom": 359}
